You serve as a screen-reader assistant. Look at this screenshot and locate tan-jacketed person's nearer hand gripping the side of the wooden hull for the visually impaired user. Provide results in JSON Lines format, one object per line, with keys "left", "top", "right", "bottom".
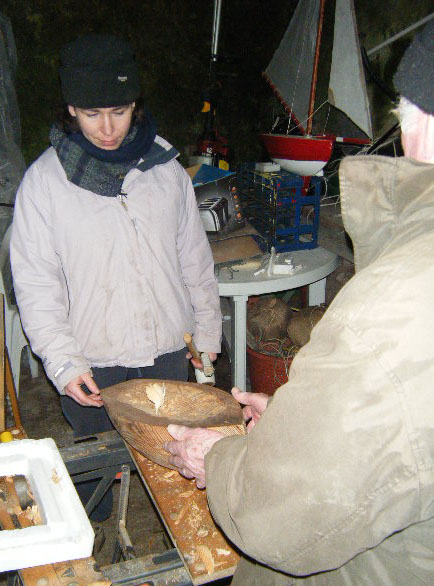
{"left": 163, "top": 424, "right": 225, "bottom": 488}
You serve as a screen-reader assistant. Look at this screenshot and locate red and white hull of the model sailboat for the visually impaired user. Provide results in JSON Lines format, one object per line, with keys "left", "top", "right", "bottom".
{"left": 261, "top": 133, "right": 335, "bottom": 176}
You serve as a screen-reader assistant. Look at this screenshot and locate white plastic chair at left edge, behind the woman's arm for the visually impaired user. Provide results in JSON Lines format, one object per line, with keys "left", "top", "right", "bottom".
{"left": 0, "top": 226, "right": 38, "bottom": 396}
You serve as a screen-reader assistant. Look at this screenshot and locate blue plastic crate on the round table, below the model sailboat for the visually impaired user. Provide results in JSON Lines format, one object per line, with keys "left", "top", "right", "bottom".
{"left": 237, "top": 163, "right": 321, "bottom": 252}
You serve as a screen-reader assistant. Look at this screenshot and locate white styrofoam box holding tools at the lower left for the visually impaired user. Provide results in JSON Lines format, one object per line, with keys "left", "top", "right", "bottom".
{"left": 0, "top": 438, "right": 94, "bottom": 572}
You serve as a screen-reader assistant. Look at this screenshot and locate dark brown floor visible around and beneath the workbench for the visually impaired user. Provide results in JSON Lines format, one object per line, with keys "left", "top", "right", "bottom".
{"left": 0, "top": 352, "right": 231, "bottom": 585}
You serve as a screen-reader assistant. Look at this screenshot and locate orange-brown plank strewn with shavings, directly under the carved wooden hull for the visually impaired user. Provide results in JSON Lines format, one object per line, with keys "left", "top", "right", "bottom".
{"left": 128, "top": 446, "right": 239, "bottom": 585}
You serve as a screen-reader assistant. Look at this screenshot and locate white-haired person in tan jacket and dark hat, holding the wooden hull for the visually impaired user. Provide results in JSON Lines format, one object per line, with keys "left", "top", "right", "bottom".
{"left": 166, "top": 21, "right": 434, "bottom": 586}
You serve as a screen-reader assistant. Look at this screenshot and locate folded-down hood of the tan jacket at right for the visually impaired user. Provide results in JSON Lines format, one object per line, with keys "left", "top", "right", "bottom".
{"left": 339, "top": 156, "right": 434, "bottom": 271}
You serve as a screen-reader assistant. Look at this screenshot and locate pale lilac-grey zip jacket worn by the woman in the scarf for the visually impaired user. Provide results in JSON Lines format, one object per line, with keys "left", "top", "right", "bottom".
{"left": 11, "top": 137, "right": 221, "bottom": 392}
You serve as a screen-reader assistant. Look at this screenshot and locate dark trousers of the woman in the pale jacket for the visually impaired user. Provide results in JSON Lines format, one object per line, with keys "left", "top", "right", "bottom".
{"left": 60, "top": 348, "right": 188, "bottom": 521}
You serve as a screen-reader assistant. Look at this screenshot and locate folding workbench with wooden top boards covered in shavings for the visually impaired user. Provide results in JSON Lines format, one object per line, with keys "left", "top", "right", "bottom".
{"left": 0, "top": 427, "right": 239, "bottom": 586}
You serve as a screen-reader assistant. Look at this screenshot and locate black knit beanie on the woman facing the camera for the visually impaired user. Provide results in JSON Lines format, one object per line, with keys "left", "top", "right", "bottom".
{"left": 59, "top": 34, "right": 140, "bottom": 108}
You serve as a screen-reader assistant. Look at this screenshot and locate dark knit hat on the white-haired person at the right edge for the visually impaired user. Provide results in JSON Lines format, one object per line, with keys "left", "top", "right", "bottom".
{"left": 393, "top": 19, "right": 434, "bottom": 116}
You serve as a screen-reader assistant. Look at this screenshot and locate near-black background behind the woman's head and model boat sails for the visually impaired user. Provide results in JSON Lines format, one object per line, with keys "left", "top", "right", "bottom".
{"left": 1, "top": 0, "right": 432, "bottom": 164}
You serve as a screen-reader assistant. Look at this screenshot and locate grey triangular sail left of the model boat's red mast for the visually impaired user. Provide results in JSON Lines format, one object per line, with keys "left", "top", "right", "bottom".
{"left": 264, "top": 0, "right": 320, "bottom": 132}
